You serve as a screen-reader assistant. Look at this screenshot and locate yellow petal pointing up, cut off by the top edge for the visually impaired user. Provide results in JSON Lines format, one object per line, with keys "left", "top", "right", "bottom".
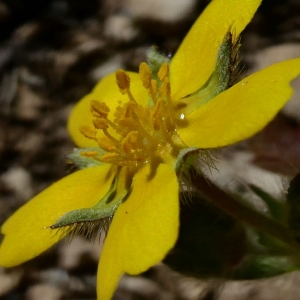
{"left": 170, "top": 0, "right": 261, "bottom": 99}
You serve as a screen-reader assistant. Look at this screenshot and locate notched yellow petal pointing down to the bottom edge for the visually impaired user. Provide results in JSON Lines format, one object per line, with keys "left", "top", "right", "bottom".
{"left": 97, "top": 164, "right": 179, "bottom": 300}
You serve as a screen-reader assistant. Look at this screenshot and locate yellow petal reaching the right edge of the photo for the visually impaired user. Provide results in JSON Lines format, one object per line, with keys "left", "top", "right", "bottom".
{"left": 178, "top": 59, "right": 300, "bottom": 148}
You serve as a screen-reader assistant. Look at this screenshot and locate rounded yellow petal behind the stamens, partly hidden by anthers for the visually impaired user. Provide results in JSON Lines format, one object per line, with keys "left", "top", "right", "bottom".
{"left": 68, "top": 72, "right": 149, "bottom": 148}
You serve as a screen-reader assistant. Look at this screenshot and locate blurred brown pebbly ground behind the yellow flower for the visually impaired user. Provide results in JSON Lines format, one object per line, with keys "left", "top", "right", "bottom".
{"left": 0, "top": 0, "right": 300, "bottom": 300}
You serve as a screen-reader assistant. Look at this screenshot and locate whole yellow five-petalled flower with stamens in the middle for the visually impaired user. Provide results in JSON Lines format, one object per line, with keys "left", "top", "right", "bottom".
{"left": 0, "top": 0, "right": 300, "bottom": 300}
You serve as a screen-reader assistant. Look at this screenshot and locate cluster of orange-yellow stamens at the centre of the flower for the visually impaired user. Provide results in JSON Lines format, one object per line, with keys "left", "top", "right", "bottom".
{"left": 80, "top": 62, "right": 184, "bottom": 168}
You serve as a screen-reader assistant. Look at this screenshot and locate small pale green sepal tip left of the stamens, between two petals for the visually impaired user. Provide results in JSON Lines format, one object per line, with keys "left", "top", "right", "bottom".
{"left": 67, "top": 147, "right": 105, "bottom": 169}
